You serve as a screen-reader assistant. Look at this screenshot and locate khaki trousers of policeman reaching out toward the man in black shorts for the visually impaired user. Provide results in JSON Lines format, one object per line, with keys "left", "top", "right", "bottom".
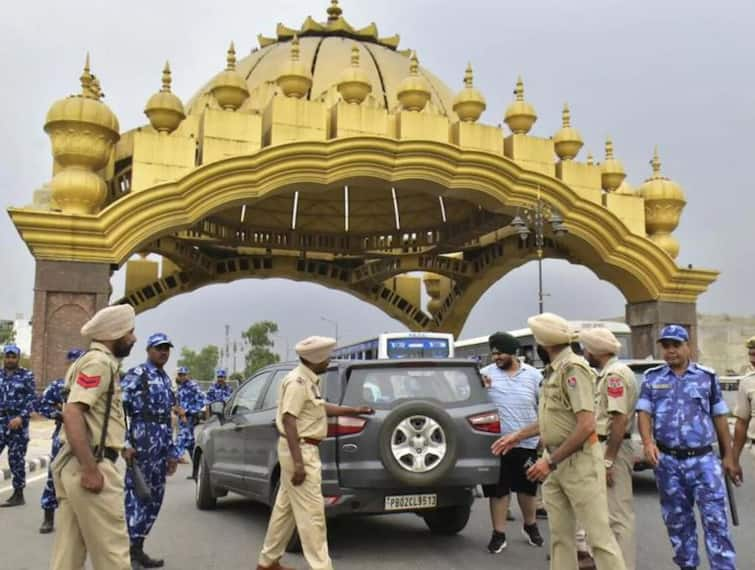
{"left": 543, "top": 444, "right": 626, "bottom": 570}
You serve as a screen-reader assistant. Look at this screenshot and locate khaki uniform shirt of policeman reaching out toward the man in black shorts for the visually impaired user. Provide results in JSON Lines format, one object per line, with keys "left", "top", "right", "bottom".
{"left": 538, "top": 348, "right": 595, "bottom": 448}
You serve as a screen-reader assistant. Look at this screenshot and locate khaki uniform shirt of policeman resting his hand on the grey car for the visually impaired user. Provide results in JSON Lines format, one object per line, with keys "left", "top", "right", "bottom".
{"left": 275, "top": 364, "right": 328, "bottom": 439}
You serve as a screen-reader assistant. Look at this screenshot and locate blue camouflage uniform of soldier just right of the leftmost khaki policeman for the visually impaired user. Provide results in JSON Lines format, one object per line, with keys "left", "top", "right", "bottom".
{"left": 121, "top": 350, "right": 178, "bottom": 543}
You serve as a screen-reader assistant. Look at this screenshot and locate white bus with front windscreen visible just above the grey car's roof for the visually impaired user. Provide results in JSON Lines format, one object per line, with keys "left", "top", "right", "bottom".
{"left": 333, "top": 332, "right": 454, "bottom": 360}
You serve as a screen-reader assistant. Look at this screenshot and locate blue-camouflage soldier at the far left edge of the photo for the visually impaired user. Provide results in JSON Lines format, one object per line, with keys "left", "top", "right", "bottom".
{"left": 0, "top": 344, "right": 36, "bottom": 507}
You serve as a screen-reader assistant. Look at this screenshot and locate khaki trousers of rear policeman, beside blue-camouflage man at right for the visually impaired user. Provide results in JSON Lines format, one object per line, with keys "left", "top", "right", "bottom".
{"left": 603, "top": 440, "right": 637, "bottom": 570}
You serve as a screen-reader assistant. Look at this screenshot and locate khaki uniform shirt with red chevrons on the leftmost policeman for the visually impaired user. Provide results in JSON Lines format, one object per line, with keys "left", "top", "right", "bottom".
{"left": 62, "top": 342, "right": 126, "bottom": 451}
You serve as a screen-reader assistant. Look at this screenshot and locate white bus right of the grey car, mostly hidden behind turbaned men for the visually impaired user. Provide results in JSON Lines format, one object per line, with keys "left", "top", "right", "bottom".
{"left": 455, "top": 321, "right": 633, "bottom": 368}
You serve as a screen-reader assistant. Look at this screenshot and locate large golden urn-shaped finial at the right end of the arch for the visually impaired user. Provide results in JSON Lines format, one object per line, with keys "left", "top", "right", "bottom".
{"left": 638, "top": 148, "right": 687, "bottom": 258}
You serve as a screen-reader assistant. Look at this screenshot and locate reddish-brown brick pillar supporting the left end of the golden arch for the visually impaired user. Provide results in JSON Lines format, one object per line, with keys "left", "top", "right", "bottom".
{"left": 31, "top": 261, "right": 110, "bottom": 390}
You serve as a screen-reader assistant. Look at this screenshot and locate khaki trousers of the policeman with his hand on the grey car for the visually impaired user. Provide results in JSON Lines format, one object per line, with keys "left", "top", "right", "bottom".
{"left": 259, "top": 438, "right": 333, "bottom": 570}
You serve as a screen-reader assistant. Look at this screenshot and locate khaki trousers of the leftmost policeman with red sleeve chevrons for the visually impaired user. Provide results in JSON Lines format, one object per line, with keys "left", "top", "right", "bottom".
{"left": 50, "top": 457, "right": 131, "bottom": 570}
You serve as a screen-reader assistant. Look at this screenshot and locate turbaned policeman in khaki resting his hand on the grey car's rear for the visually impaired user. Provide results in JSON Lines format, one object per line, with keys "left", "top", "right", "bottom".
{"left": 257, "top": 336, "right": 375, "bottom": 570}
